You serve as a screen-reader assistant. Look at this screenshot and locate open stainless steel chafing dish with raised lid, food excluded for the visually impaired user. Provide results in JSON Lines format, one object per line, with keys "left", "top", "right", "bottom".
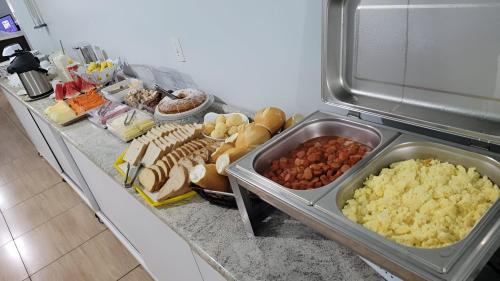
{"left": 228, "top": 0, "right": 500, "bottom": 280}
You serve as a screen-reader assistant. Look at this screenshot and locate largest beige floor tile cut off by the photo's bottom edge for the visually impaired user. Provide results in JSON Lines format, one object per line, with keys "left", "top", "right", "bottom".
{"left": 32, "top": 230, "right": 138, "bottom": 281}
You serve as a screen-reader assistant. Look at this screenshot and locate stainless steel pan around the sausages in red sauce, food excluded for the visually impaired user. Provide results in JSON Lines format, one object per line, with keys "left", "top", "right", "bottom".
{"left": 254, "top": 112, "right": 397, "bottom": 205}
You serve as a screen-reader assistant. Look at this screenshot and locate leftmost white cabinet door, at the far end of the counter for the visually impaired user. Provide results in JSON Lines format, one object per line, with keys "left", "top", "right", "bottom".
{"left": 4, "top": 91, "right": 62, "bottom": 173}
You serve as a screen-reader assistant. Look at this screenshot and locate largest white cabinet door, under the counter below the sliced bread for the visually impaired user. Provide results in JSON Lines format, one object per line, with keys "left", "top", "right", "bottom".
{"left": 68, "top": 145, "right": 203, "bottom": 281}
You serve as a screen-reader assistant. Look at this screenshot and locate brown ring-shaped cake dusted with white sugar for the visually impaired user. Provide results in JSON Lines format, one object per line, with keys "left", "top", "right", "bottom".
{"left": 158, "top": 89, "right": 207, "bottom": 114}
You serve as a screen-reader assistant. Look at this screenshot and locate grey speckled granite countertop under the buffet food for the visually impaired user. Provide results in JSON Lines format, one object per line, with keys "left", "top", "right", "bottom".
{"left": 0, "top": 78, "right": 383, "bottom": 281}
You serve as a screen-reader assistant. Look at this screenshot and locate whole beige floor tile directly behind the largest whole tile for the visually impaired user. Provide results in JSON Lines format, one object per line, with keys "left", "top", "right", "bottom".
{"left": 4, "top": 182, "right": 80, "bottom": 238}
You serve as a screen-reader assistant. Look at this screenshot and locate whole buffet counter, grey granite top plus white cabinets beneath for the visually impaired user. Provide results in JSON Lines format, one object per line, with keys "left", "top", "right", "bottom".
{"left": 0, "top": 79, "right": 382, "bottom": 281}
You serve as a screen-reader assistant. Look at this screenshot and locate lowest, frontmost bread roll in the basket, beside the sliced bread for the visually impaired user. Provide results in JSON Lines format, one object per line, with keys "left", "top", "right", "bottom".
{"left": 189, "top": 164, "right": 229, "bottom": 192}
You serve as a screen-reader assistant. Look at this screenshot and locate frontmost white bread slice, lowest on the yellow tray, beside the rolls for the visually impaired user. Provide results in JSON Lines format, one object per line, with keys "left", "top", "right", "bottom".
{"left": 157, "top": 165, "right": 190, "bottom": 201}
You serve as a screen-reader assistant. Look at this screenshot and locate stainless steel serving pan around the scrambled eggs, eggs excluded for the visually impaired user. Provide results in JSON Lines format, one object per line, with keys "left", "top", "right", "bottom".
{"left": 314, "top": 135, "right": 500, "bottom": 279}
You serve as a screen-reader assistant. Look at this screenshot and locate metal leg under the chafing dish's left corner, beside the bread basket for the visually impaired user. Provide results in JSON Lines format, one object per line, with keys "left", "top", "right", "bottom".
{"left": 229, "top": 176, "right": 275, "bottom": 238}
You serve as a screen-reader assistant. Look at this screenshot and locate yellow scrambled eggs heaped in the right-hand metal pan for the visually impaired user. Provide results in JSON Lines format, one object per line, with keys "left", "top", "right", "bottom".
{"left": 342, "top": 159, "right": 500, "bottom": 248}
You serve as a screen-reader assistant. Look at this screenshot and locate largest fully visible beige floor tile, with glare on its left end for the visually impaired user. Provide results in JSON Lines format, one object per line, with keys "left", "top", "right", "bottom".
{"left": 15, "top": 203, "right": 105, "bottom": 274}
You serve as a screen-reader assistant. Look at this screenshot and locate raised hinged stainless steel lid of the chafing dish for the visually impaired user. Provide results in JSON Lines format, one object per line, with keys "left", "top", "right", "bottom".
{"left": 322, "top": 0, "right": 500, "bottom": 146}
